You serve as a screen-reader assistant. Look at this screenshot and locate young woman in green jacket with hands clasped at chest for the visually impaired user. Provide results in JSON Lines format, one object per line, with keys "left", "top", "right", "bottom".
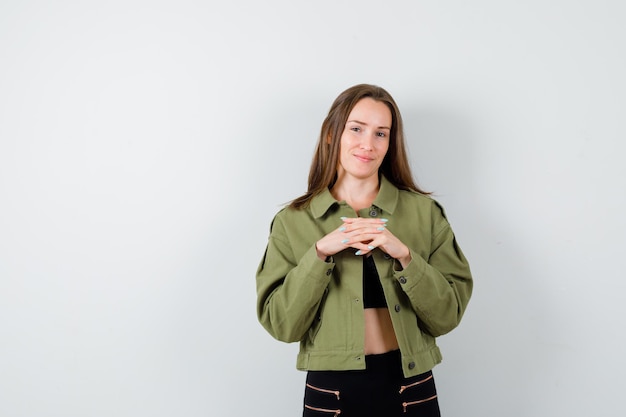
{"left": 256, "top": 84, "right": 472, "bottom": 417}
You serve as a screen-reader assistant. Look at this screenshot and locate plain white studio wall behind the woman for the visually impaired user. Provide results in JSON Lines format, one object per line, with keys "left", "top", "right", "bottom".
{"left": 0, "top": 0, "right": 626, "bottom": 417}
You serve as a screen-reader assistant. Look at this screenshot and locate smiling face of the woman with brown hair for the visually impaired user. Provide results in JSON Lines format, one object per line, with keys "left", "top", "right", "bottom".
{"left": 337, "top": 97, "right": 391, "bottom": 180}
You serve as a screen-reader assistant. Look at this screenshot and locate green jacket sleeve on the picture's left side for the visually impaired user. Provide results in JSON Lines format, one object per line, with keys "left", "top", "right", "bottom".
{"left": 256, "top": 213, "right": 335, "bottom": 342}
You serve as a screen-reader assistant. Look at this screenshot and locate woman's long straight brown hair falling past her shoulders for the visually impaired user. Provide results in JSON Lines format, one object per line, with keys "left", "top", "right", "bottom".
{"left": 290, "top": 84, "right": 429, "bottom": 209}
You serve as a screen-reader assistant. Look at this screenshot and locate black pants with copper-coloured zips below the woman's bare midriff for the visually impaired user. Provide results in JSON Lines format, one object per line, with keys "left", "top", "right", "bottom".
{"left": 303, "top": 350, "right": 440, "bottom": 417}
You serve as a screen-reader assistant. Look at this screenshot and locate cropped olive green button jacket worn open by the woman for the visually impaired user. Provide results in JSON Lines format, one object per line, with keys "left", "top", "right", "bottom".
{"left": 256, "top": 176, "right": 473, "bottom": 377}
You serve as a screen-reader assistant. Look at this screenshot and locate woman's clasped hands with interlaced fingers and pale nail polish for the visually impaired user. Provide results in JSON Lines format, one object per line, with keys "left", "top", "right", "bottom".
{"left": 315, "top": 217, "right": 411, "bottom": 267}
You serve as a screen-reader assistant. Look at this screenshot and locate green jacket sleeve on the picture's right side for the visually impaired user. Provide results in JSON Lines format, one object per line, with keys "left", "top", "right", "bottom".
{"left": 394, "top": 203, "right": 473, "bottom": 337}
